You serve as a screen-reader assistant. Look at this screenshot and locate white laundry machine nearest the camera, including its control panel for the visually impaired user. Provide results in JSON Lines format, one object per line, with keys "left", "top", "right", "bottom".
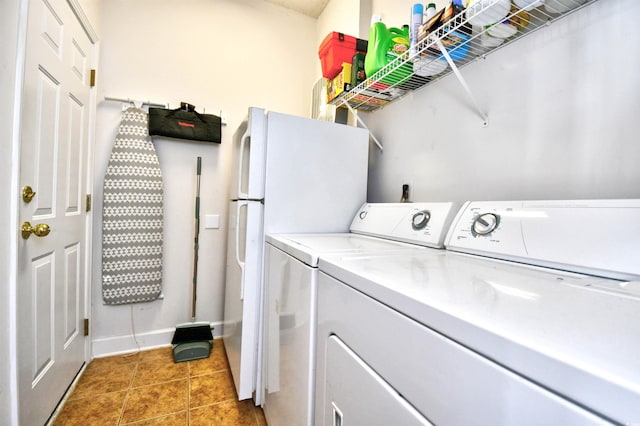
{"left": 315, "top": 200, "right": 640, "bottom": 426}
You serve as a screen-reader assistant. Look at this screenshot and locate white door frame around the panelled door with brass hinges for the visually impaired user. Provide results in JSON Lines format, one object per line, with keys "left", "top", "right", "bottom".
{"left": 0, "top": 0, "right": 99, "bottom": 426}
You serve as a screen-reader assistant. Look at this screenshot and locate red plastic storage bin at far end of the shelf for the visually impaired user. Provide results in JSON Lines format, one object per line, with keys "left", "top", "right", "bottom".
{"left": 318, "top": 31, "right": 367, "bottom": 79}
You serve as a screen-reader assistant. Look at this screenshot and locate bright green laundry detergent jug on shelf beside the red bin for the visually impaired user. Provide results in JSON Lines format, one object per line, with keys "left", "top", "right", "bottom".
{"left": 364, "top": 17, "right": 413, "bottom": 85}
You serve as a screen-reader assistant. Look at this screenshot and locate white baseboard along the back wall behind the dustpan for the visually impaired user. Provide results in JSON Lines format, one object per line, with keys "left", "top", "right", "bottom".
{"left": 91, "top": 322, "right": 222, "bottom": 358}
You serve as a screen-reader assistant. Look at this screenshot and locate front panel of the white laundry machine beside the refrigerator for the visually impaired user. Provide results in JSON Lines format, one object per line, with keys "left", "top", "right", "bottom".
{"left": 264, "top": 244, "right": 318, "bottom": 426}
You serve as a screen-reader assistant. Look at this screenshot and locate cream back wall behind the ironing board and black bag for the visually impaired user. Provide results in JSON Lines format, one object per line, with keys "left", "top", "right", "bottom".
{"left": 91, "top": 0, "right": 317, "bottom": 355}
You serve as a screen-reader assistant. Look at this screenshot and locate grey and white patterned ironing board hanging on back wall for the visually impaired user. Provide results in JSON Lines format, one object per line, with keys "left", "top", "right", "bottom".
{"left": 102, "top": 107, "right": 163, "bottom": 305}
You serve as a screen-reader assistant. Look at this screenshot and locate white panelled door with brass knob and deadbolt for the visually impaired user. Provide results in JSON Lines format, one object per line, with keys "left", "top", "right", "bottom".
{"left": 16, "top": 0, "right": 93, "bottom": 425}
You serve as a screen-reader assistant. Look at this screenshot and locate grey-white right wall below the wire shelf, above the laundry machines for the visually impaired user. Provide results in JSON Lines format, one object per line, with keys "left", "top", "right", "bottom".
{"left": 364, "top": 0, "right": 640, "bottom": 202}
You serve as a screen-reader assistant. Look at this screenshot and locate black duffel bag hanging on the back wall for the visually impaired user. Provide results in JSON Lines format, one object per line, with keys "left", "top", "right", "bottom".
{"left": 149, "top": 102, "right": 222, "bottom": 143}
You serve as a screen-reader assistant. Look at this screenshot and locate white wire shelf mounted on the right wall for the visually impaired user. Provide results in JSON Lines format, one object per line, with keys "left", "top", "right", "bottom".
{"left": 330, "top": 0, "right": 597, "bottom": 111}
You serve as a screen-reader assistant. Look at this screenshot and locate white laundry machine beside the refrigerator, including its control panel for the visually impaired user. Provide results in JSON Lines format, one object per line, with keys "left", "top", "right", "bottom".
{"left": 263, "top": 203, "right": 457, "bottom": 426}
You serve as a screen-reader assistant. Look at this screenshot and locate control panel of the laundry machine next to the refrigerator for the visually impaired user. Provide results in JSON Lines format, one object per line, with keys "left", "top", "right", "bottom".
{"left": 350, "top": 202, "right": 457, "bottom": 248}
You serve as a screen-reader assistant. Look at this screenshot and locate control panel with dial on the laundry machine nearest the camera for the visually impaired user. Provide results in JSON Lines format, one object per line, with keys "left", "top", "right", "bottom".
{"left": 445, "top": 199, "right": 640, "bottom": 280}
